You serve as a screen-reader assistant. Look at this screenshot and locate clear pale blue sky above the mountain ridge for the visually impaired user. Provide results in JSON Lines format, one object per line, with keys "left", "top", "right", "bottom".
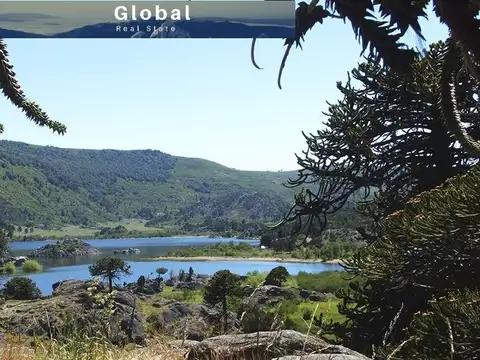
{"left": 0, "top": 5, "right": 447, "bottom": 171}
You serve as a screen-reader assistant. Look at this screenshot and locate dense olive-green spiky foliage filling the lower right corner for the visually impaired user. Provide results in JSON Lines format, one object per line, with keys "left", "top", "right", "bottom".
{"left": 322, "top": 166, "right": 480, "bottom": 359}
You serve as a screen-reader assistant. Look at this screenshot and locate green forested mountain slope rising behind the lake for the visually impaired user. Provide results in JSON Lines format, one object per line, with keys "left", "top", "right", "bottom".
{"left": 0, "top": 140, "right": 295, "bottom": 226}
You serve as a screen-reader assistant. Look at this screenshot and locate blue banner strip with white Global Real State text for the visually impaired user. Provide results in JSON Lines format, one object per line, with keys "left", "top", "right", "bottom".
{"left": 0, "top": 0, "right": 295, "bottom": 39}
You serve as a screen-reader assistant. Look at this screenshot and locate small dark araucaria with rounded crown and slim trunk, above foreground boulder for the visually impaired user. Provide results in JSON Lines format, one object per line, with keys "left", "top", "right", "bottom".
{"left": 203, "top": 270, "right": 241, "bottom": 333}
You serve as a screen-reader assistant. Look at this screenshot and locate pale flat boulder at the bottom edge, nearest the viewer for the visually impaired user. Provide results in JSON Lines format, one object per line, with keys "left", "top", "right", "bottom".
{"left": 172, "top": 330, "right": 368, "bottom": 360}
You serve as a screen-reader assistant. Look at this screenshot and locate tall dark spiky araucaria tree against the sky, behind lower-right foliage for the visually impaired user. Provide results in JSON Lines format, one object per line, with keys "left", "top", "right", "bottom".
{"left": 285, "top": 43, "right": 480, "bottom": 241}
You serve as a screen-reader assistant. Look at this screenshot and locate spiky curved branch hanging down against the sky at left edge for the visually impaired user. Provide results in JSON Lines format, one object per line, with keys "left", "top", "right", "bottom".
{"left": 0, "top": 39, "right": 67, "bottom": 135}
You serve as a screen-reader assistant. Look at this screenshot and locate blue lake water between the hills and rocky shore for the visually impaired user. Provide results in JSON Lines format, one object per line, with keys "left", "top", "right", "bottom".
{"left": 10, "top": 238, "right": 342, "bottom": 295}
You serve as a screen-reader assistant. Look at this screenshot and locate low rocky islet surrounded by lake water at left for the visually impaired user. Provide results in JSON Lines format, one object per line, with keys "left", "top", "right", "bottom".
{"left": 29, "top": 240, "right": 100, "bottom": 259}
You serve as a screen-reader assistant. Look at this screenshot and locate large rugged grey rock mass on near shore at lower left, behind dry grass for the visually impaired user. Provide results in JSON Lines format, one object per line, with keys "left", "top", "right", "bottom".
{"left": 0, "top": 280, "right": 145, "bottom": 344}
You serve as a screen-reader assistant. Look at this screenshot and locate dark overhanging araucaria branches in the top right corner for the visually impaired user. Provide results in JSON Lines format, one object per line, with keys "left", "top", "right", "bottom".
{"left": 251, "top": 0, "right": 480, "bottom": 158}
